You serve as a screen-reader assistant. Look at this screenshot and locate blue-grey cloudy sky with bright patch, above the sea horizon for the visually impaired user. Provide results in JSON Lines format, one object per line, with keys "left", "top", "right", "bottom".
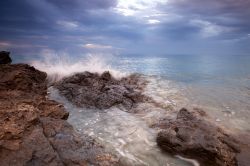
{"left": 0, "top": 0, "right": 250, "bottom": 55}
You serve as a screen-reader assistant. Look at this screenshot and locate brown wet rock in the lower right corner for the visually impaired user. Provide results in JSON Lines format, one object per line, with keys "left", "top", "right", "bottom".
{"left": 157, "top": 109, "right": 250, "bottom": 166}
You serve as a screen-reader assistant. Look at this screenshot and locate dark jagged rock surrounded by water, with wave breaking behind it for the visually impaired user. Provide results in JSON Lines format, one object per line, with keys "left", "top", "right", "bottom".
{"left": 55, "top": 71, "right": 147, "bottom": 109}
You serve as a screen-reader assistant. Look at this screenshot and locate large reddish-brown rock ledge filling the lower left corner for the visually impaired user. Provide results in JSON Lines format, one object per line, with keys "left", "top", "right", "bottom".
{"left": 0, "top": 64, "right": 118, "bottom": 166}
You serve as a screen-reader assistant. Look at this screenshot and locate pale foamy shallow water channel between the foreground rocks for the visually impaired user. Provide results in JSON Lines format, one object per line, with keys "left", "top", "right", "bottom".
{"left": 49, "top": 88, "right": 192, "bottom": 166}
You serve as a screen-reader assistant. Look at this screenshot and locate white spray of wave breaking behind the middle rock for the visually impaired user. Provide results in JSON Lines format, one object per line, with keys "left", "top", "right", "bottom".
{"left": 31, "top": 53, "right": 128, "bottom": 82}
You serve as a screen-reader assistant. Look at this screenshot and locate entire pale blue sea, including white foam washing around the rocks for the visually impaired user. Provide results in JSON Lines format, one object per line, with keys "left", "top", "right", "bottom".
{"left": 16, "top": 54, "right": 250, "bottom": 166}
